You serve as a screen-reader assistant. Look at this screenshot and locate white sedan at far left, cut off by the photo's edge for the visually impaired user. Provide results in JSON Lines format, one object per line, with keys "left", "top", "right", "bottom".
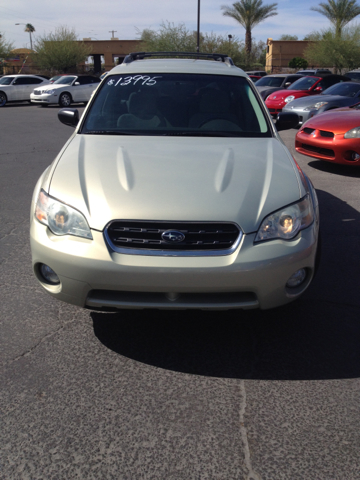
{"left": 0, "top": 74, "right": 49, "bottom": 107}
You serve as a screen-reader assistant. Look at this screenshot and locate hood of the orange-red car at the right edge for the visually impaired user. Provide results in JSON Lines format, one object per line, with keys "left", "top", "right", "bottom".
{"left": 302, "top": 107, "right": 360, "bottom": 135}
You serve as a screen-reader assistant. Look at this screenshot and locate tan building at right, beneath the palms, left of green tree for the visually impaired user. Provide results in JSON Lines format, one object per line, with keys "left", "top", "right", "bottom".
{"left": 265, "top": 38, "right": 310, "bottom": 73}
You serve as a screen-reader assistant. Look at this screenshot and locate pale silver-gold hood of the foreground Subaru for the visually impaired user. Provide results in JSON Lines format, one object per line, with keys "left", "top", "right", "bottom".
{"left": 49, "top": 134, "right": 305, "bottom": 233}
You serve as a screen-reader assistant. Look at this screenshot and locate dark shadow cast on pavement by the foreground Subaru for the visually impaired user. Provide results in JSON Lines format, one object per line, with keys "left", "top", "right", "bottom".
{"left": 91, "top": 191, "right": 360, "bottom": 380}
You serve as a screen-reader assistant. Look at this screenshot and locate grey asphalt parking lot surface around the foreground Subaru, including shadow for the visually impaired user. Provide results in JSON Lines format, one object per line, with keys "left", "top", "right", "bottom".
{"left": 0, "top": 103, "right": 360, "bottom": 480}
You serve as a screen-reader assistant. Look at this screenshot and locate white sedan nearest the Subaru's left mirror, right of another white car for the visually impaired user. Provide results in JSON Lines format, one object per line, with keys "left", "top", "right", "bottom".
{"left": 30, "top": 75, "right": 100, "bottom": 107}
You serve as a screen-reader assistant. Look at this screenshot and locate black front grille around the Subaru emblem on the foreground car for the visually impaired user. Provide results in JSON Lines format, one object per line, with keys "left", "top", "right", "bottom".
{"left": 105, "top": 220, "right": 241, "bottom": 255}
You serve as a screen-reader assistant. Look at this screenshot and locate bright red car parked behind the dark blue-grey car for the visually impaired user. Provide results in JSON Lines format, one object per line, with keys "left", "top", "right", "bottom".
{"left": 265, "top": 75, "right": 349, "bottom": 117}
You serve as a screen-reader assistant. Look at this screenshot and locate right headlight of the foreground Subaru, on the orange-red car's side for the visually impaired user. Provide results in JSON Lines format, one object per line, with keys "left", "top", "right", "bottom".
{"left": 255, "top": 194, "right": 314, "bottom": 242}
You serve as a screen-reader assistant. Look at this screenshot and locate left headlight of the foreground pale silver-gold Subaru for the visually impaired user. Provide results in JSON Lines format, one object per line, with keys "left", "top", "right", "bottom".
{"left": 35, "top": 190, "right": 93, "bottom": 240}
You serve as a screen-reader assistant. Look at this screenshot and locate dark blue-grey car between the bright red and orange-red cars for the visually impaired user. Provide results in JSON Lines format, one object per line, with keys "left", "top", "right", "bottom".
{"left": 283, "top": 82, "right": 360, "bottom": 125}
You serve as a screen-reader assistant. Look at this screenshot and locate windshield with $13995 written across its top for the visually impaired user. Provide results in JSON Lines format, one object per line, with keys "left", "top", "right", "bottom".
{"left": 81, "top": 73, "right": 271, "bottom": 137}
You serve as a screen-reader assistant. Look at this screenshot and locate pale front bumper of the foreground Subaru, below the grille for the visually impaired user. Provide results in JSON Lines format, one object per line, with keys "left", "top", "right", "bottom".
{"left": 30, "top": 219, "right": 318, "bottom": 310}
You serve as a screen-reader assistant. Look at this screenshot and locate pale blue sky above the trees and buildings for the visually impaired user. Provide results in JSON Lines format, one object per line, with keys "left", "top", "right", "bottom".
{"left": 0, "top": 0, "right": 352, "bottom": 48}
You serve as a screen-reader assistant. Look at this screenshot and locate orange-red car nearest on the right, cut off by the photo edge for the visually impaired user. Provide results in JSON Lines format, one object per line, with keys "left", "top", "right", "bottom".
{"left": 295, "top": 103, "right": 360, "bottom": 166}
